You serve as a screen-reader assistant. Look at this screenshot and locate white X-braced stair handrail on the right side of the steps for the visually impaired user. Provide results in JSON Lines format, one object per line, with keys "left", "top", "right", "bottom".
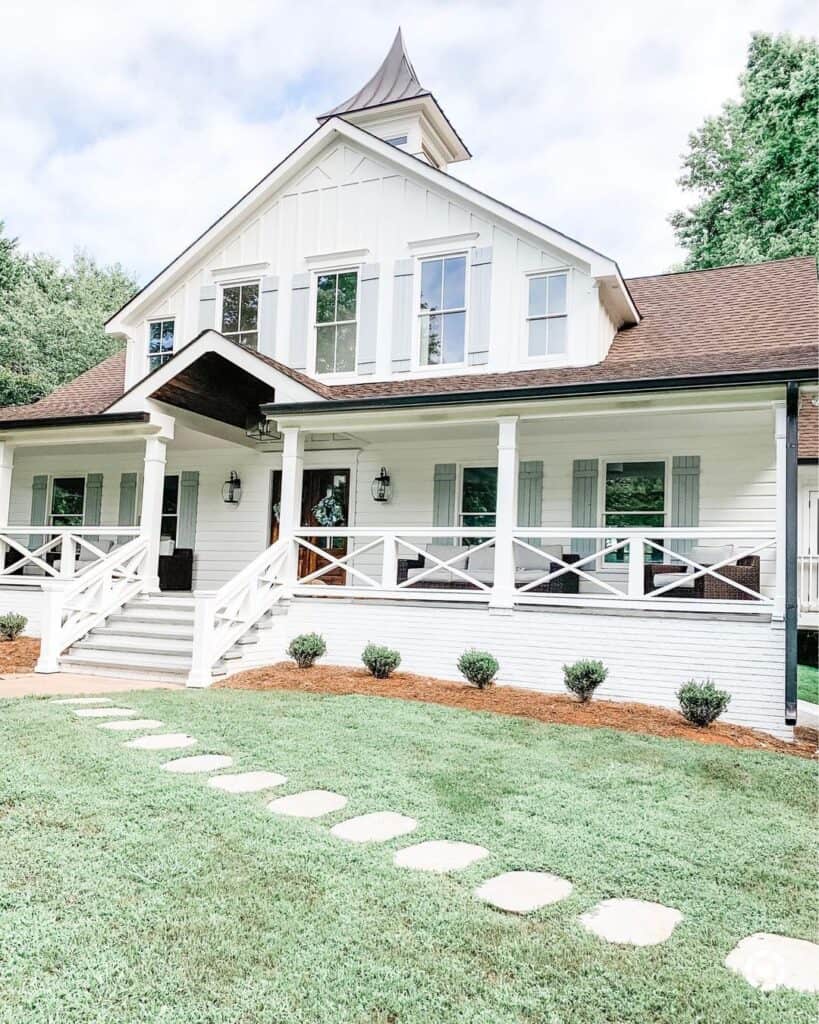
{"left": 187, "top": 539, "right": 292, "bottom": 686}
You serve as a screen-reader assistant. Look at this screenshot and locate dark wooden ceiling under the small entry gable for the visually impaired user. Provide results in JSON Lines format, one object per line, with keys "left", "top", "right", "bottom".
{"left": 150, "top": 352, "right": 275, "bottom": 430}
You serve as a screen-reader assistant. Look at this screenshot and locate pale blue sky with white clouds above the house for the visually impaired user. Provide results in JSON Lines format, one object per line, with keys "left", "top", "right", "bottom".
{"left": 0, "top": 0, "right": 817, "bottom": 281}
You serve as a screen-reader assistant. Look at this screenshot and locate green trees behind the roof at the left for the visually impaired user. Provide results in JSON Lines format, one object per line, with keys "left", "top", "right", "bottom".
{"left": 0, "top": 221, "right": 136, "bottom": 406}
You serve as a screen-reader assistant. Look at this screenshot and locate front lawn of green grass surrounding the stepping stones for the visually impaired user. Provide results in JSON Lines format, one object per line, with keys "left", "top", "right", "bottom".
{"left": 0, "top": 690, "right": 817, "bottom": 1024}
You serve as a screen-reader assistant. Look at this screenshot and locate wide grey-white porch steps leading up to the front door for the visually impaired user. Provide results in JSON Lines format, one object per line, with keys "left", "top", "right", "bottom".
{"left": 59, "top": 595, "right": 284, "bottom": 684}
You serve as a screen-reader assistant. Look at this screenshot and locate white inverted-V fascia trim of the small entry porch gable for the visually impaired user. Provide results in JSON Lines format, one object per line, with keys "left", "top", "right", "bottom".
{"left": 106, "top": 331, "right": 327, "bottom": 413}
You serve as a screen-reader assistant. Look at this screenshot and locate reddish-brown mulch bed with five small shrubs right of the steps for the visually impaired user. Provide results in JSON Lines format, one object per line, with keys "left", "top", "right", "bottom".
{"left": 215, "top": 662, "right": 818, "bottom": 758}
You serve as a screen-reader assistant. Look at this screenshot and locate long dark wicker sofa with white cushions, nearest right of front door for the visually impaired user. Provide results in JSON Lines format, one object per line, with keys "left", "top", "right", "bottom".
{"left": 397, "top": 544, "right": 580, "bottom": 594}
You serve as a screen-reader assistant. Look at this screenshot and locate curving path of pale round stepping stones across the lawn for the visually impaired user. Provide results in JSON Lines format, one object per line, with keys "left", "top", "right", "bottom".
{"left": 59, "top": 697, "right": 819, "bottom": 993}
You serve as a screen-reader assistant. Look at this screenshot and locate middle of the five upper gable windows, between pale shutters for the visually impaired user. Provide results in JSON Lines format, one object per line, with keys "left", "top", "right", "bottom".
{"left": 315, "top": 270, "right": 358, "bottom": 374}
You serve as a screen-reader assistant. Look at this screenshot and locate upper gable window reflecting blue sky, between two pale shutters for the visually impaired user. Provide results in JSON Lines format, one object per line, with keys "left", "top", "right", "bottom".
{"left": 419, "top": 254, "right": 467, "bottom": 367}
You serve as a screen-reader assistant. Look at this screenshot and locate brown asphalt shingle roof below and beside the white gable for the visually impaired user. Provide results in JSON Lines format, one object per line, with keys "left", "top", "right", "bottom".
{"left": 0, "top": 257, "right": 819, "bottom": 428}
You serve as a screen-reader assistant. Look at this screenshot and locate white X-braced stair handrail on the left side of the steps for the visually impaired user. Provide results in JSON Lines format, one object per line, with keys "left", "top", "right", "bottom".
{"left": 34, "top": 537, "right": 148, "bottom": 673}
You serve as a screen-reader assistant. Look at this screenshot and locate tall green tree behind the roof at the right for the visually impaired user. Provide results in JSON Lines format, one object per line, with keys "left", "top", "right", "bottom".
{"left": 671, "top": 34, "right": 819, "bottom": 269}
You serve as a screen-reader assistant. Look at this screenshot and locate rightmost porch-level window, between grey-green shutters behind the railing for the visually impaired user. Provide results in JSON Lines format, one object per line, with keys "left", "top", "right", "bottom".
{"left": 603, "top": 462, "right": 666, "bottom": 563}
